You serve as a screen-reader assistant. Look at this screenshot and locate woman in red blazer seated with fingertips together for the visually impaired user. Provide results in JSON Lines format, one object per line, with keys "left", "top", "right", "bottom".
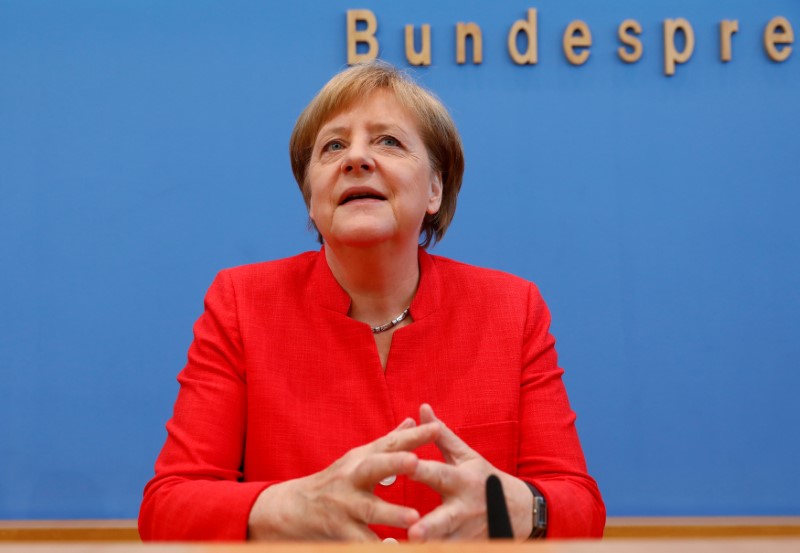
{"left": 139, "top": 62, "right": 605, "bottom": 541}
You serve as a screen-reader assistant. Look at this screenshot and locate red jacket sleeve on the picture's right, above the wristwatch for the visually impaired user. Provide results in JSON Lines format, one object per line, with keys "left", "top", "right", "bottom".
{"left": 518, "top": 284, "right": 606, "bottom": 538}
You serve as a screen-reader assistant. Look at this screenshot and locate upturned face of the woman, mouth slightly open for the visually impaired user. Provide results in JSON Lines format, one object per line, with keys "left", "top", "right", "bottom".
{"left": 307, "top": 89, "right": 442, "bottom": 246}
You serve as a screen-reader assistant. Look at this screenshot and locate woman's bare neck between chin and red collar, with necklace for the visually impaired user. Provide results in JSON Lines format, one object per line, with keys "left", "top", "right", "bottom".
{"left": 325, "top": 239, "right": 419, "bottom": 326}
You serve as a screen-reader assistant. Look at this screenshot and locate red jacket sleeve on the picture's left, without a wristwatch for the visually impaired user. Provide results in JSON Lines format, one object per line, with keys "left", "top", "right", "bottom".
{"left": 139, "top": 271, "right": 270, "bottom": 541}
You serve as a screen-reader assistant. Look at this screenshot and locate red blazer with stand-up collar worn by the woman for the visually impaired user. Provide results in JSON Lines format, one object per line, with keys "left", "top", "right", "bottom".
{"left": 139, "top": 250, "right": 605, "bottom": 540}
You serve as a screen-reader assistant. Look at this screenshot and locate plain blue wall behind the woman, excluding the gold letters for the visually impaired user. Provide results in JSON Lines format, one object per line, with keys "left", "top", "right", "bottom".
{"left": 0, "top": 0, "right": 800, "bottom": 518}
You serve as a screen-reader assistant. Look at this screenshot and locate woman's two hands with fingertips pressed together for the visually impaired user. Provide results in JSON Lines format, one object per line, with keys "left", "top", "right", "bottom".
{"left": 248, "top": 404, "right": 531, "bottom": 541}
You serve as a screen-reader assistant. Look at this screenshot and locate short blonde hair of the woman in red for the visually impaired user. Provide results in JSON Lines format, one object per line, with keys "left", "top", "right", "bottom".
{"left": 289, "top": 61, "right": 464, "bottom": 248}
